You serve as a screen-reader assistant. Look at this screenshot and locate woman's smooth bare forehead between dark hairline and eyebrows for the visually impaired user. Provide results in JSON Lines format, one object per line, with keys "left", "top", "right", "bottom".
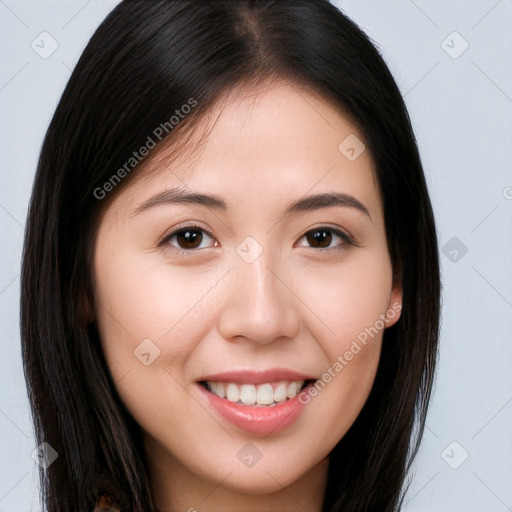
{"left": 107, "top": 82, "right": 380, "bottom": 218}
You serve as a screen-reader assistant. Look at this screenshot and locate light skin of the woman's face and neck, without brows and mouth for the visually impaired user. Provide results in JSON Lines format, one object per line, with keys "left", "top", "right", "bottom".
{"left": 93, "top": 82, "right": 401, "bottom": 512}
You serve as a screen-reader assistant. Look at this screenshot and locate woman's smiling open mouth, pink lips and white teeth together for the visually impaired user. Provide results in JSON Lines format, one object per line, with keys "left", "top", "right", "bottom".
{"left": 197, "top": 370, "right": 317, "bottom": 435}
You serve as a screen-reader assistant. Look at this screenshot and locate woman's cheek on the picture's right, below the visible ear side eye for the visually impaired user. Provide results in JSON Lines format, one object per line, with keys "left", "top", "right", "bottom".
{"left": 290, "top": 246, "right": 392, "bottom": 424}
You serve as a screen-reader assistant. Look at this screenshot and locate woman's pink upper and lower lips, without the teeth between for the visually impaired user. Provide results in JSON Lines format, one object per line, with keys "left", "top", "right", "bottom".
{"left": 198, "top": 369, "right": 314, "bottom": 435}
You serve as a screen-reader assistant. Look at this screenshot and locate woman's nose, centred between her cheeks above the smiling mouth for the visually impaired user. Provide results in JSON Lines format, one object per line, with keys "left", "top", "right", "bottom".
{"left": 218, "top": 251, "right": 300, "bottom": 345}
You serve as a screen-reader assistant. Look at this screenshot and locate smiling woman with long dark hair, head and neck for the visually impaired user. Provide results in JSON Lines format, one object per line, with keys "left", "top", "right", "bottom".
{"left": 22, "top": 0, "right": 440, "bottom": 512}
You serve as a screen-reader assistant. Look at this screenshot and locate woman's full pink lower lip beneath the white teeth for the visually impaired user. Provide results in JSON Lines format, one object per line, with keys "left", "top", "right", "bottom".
{"left": 198, "top": 384, "right": 304, "bottom": 435}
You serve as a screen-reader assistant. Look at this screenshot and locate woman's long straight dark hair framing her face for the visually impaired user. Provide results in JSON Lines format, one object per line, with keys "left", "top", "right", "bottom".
{"left": 21, "top": 0, "right": 440, "bottom": 512}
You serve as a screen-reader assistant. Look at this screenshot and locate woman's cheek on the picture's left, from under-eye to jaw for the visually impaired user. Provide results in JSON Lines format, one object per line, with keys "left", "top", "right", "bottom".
{"left": 95, "top": 251, "right": 226, "bottom": 432}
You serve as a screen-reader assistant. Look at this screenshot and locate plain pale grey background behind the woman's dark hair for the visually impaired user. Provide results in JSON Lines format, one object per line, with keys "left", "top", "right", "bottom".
{"left": 0, "top": 0, "right": 512, "bottom": 512}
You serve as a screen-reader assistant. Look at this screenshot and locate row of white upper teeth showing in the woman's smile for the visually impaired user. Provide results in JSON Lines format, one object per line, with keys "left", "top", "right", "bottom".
{"left": 206, "top": 380, "right": 304, "bottom": 405}
